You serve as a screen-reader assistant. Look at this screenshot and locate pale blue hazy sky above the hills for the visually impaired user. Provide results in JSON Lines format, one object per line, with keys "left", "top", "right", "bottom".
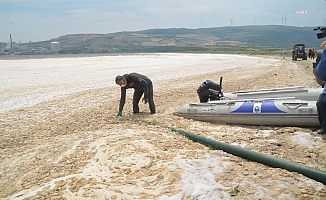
{"left": 0, "top": 0, "right": 326, "bottom": 42}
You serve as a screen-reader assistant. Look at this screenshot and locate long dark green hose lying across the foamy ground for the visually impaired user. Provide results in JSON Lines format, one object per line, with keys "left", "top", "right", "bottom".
{"left": 129, "top": 117, "right": 326, "bottom": 185}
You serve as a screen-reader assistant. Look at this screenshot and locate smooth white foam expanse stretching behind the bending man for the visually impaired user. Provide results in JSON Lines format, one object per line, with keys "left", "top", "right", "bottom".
{"left": 0, "top": 53, "right": 277, "bottom": 112}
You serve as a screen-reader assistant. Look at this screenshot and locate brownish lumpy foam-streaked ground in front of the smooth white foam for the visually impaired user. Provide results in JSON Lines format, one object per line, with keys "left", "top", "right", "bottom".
{"left": 0, "top": 54, "right": 326, "bottom": 200}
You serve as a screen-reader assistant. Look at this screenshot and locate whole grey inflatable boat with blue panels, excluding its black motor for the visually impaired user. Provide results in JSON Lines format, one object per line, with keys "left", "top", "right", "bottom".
{"left": 180, "top": 77, "right": 323, "bottom": 127}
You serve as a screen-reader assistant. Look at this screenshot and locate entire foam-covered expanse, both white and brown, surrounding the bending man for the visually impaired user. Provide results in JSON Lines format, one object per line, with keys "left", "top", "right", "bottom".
{"left": 0, "top": 54, "right": 326, "bottom": 200}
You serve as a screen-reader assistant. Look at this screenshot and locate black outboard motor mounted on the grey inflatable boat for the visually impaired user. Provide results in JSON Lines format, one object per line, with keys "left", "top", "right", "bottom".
{"left": 197, "top": 80, "right": 221, "bottom": 103}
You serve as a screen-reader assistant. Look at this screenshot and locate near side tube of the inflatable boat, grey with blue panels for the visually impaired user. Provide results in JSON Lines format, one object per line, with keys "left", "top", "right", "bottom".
{"left": 174, "top": 97, "right": 320, "bottom": 127}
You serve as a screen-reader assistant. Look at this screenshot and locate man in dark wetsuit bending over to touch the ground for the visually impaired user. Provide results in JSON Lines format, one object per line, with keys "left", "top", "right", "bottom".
{"left": 115, "top": 73, "right": 156, "bottom": 116}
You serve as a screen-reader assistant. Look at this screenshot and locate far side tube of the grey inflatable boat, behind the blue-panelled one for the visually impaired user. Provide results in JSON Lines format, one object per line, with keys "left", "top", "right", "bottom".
{"left": 215, "top": 86, "right": 323, "bottom": 101}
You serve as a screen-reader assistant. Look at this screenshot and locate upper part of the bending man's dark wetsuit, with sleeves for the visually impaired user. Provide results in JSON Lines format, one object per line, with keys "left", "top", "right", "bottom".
{"left": 119, "top": 73, "right": 152, "bottom": 112}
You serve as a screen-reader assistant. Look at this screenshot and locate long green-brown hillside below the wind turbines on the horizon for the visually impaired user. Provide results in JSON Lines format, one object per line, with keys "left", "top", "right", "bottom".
{"left": 27, "top": 25, "right": 321, "bottom": 54}
